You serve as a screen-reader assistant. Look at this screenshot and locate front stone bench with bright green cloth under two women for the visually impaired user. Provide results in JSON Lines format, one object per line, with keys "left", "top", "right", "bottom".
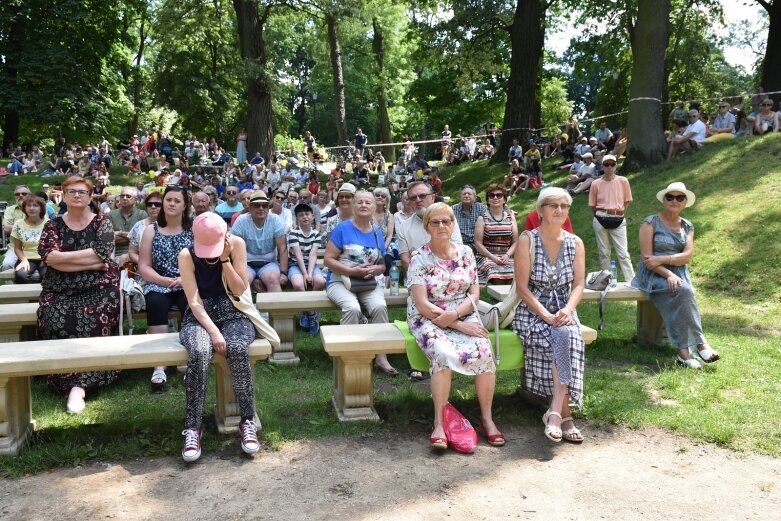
{"left": 320, "top": 324, "right": 597, "bottom": 421}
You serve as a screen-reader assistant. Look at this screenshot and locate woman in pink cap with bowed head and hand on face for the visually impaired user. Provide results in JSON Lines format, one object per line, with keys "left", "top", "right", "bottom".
{"left": 179, "top": 212, "right": 260, "bottom": 462}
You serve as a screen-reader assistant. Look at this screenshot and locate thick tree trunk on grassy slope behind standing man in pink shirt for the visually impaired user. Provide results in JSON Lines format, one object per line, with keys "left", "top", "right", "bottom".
{"left": 624, "top": 0, "right": 670, "bottom": 171}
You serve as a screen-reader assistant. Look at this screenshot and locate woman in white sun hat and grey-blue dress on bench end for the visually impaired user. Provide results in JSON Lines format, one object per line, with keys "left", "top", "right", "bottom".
{"left": 632, "top": 182, "right": 719, "bottom": 369}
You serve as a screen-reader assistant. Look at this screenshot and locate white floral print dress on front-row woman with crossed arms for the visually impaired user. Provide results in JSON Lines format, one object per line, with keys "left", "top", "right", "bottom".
{"left": 407, "top": 244, "right": 496, "bottom": 375}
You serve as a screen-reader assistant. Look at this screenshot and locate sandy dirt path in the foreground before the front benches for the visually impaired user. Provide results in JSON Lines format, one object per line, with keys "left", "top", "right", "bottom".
{"left": 0, "top": 426, "right": 781, "bottom": 521}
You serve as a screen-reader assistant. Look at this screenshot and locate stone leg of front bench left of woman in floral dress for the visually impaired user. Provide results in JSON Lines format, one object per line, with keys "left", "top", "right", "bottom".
{"left": 333, "top": 353, "right": 380, "bottom": 421}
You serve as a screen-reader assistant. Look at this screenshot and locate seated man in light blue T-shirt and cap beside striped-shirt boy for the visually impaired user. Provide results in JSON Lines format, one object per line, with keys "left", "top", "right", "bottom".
{"left": 231, "top": 190, "right": 288, "bottom": 293}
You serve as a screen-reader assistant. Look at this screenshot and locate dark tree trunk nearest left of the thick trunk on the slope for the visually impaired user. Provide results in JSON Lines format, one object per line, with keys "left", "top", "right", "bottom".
{"left": 493, "top": 0, "right": 546, "bottom": 163}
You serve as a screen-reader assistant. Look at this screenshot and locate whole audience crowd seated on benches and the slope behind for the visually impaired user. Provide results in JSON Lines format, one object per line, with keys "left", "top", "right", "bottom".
{"left": 3, "top": 101, "right": 736, "bottom": 461}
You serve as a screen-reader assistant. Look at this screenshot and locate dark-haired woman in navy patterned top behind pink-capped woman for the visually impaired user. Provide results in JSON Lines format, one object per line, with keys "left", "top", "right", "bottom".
{"left": 138, "top": 186, "right": 193, "bottom": 391}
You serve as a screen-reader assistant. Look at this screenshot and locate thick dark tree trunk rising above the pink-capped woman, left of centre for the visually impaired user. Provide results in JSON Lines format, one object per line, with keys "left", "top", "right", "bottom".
{"left": 233, "top": 0, "right": 274, "bottom": 158}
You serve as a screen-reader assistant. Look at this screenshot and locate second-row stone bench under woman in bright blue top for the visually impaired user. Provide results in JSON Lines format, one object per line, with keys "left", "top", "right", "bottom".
{"left": 255, "top": 288, "right": 407, "bottom": 365}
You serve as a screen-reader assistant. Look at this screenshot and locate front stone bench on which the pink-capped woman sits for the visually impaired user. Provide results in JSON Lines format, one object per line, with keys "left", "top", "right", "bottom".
{"left": 0, "top": 333, "right": 271, "bottom": 454}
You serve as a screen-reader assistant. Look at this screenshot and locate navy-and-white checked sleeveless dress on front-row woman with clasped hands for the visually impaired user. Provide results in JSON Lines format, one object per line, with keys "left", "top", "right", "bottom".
{"left": 513, "top": 229, "right": 586, "bottom": 407}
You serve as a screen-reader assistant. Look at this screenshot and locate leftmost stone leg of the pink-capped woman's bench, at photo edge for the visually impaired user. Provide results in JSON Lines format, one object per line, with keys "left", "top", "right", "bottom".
{"left": 0, "top": 376, "right": 35, "bottom": 455}
